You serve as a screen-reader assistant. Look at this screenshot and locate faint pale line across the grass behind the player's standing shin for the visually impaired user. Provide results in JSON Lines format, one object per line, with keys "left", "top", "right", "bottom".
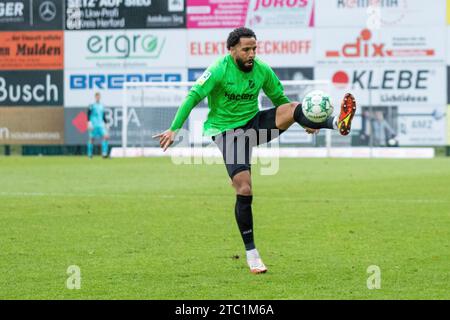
{"left": 0, "top": 192, "right": 450, "bottom": 203}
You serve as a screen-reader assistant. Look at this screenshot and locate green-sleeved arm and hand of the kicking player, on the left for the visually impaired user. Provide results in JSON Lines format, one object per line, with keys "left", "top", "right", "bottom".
{"left": 153, "top": 67, "right": 219, "bottom": 151}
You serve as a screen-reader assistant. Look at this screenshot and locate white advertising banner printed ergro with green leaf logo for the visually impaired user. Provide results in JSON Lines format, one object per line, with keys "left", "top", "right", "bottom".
{"left": 65, "top": 29, "right": 187, "bottom": 69}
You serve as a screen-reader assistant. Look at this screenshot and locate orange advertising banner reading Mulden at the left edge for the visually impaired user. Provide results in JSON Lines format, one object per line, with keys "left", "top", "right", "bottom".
{"left": 0, "top": 31, "right": 64, "bottom": 70}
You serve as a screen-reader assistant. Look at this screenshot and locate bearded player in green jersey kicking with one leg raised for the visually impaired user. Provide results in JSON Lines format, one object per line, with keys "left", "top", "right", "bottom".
{"left": 154, "top": 27, "right": 356, "bottom": 273}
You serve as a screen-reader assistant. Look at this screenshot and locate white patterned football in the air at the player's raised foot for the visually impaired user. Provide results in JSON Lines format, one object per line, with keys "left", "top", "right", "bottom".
{"left": 302, "top": 90, "right": 333, "bottom": 123}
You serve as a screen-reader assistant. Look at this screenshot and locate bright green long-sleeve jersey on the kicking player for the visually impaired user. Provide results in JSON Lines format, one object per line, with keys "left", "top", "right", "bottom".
{"left": 170, "top": 54, "right": 289, "bottom": 136}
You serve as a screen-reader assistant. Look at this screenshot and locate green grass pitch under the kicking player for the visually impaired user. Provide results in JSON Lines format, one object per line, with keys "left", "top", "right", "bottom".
{"left": 0, "top": 157, "right": 450, "bottom": 299}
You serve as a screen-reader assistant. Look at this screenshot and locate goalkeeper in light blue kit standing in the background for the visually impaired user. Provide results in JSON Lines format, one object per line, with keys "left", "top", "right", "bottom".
{"left": 87, "top": 92, "right": 109, "bottom": 159}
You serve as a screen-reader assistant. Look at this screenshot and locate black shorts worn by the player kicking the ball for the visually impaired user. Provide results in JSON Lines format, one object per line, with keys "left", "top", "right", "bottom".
{"left": 212, "top": 108, "right": 284, "bottom": 179}
